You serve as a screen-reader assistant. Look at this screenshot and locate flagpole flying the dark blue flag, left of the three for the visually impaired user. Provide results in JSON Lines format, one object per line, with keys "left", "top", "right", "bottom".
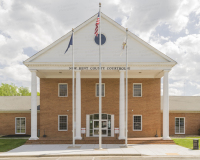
{"left": 72, "top": 28, "right": 75, "bottom": 147}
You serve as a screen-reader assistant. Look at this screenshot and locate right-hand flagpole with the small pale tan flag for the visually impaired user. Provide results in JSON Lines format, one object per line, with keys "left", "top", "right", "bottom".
{"left": 125, "top": 28, "right": 128, "bottom": 147}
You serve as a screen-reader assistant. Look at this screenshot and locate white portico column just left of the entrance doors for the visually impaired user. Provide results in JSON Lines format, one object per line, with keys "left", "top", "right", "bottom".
{"left": 75, "top": 71, "right": 82, "bottom": 139}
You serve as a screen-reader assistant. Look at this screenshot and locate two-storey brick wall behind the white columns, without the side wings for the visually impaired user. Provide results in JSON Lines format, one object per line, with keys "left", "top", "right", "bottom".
{"left": 40, "top": 78, "right": 161, "bottom": 138}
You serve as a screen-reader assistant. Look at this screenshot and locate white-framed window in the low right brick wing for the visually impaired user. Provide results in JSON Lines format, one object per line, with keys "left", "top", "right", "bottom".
{"left": 175, "top": 117, "right": 185, "bottom": 134}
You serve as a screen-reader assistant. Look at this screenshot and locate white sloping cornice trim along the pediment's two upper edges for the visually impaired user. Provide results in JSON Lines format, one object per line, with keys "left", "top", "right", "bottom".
{"left": 24, "top": 13, "right": 177, "bottom": 66}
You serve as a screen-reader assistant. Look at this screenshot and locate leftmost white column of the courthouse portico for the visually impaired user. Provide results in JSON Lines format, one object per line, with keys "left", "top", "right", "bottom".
{"left": 29, "top": 70, "right": 38, "bottom": 140}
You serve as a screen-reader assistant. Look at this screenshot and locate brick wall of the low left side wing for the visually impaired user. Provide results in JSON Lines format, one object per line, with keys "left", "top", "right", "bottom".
{"left": 0, "top": 113, "right": 40, "bottom": 135}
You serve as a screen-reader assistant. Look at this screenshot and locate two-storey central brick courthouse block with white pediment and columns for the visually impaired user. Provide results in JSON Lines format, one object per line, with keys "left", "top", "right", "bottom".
{"left": 0, "top": 13, "right": 197, "bottom": 140}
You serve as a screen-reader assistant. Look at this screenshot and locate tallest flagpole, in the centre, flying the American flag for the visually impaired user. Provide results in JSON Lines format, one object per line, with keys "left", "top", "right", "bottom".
{"left": 99, "top": 3, "right": 102, "bottom": 149}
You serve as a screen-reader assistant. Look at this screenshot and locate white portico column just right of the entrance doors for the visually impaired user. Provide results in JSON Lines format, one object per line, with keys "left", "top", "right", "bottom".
{"left": 118, "top": 71, "right": 125, "bottom": 139}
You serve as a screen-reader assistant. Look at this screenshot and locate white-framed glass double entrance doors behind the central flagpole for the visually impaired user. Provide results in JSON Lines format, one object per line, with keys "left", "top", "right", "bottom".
{"left": 93, "top": 120, "right": 108, "bottom": 137}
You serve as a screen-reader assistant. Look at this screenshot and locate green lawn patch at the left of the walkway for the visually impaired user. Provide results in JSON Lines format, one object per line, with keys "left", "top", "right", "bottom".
{"left": 0, "top": 139, "right": 27, "bottom": 152}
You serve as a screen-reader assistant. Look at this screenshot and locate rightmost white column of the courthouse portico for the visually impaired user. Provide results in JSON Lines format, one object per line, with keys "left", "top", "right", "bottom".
{"left": 163, "top": 70, "right": 170, "bottom": 140}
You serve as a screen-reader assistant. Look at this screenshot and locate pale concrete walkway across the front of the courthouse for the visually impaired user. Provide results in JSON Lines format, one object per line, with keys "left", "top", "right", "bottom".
{"left": 0, "top": 144, "right": 200, "bottom": 157}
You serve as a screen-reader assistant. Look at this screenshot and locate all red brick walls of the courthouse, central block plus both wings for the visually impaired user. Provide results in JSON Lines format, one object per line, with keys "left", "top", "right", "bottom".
{"left": 0, "top": 78, "right": 200, "bottom": 138}
